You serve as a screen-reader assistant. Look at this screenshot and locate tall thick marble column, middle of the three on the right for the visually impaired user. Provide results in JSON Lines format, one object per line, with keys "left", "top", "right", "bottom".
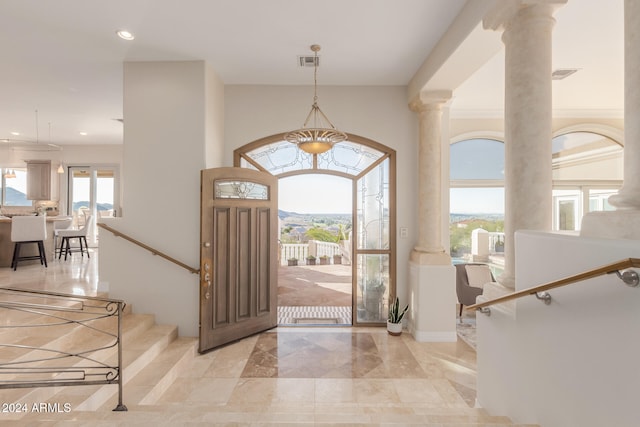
{"left": 484, "top": 0, "right": 564, "bottom": 289}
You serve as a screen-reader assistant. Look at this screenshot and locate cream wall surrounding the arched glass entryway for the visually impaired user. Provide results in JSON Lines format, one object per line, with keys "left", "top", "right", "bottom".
{"left": 225, "top": 85, "right": 418, "bottom": 308}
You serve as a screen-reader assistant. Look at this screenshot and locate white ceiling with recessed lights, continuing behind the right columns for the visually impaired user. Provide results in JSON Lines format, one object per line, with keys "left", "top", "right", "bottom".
{"left": 0, "top": 0, "right": 623, "bottom": 144}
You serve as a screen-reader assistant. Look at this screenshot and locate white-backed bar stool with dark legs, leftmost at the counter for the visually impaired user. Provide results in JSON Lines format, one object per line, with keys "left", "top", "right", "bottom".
{"left": 11, "top": 215, "right": 47, "bottom": 271}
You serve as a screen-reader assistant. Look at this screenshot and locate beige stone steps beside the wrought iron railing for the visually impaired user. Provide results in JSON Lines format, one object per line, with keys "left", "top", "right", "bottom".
{"left": 0, "top": 300, "right": 197, "bottom": 425}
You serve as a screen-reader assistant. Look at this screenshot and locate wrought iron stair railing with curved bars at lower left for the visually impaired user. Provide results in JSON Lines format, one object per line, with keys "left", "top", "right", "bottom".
{"left": 0, "top": 288, "right": 127, "bottom": 411}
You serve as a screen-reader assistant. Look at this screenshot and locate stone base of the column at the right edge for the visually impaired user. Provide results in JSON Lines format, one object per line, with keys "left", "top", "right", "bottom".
{"left": 580, "top": 209, "right": 640, "bottom": 240}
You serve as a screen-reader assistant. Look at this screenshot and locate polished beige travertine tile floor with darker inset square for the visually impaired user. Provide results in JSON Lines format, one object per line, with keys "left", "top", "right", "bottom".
{"left": 0, "top": 252, "right": 528, "bottom": 426}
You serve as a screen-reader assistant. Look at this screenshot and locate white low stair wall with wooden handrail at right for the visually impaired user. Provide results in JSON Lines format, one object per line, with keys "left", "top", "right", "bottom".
{"left": 477, "top": 231, "right": 640, "bottom": 427}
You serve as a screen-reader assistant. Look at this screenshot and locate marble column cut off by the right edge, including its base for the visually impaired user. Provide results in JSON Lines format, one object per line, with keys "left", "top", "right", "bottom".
{"left": 580, "top": 0, "right": 640, "bottom": 240}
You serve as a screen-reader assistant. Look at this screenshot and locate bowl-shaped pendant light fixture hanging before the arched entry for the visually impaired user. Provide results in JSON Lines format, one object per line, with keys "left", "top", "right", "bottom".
{"left": 284, "top": 44, "right": 347, "bottom": 154}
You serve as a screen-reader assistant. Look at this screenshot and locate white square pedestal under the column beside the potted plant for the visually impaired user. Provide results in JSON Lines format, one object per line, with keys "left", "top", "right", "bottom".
{"left": 407, "top": 262, "right": 458, "bottom": 342}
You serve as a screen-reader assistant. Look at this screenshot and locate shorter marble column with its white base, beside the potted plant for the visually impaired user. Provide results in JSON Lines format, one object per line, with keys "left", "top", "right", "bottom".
{"left": 408, "top": 91, "right": 457, "bottom": 342}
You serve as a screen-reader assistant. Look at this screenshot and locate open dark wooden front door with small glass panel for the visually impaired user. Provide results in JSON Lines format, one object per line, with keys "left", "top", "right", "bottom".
{"left": 199, "top": 168, "right": 278, "bottom": 353}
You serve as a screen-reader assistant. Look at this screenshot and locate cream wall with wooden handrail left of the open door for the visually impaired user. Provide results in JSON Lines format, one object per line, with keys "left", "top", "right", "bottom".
{"left": 99, "top": 61, "right": 224, "bottom": 336}
